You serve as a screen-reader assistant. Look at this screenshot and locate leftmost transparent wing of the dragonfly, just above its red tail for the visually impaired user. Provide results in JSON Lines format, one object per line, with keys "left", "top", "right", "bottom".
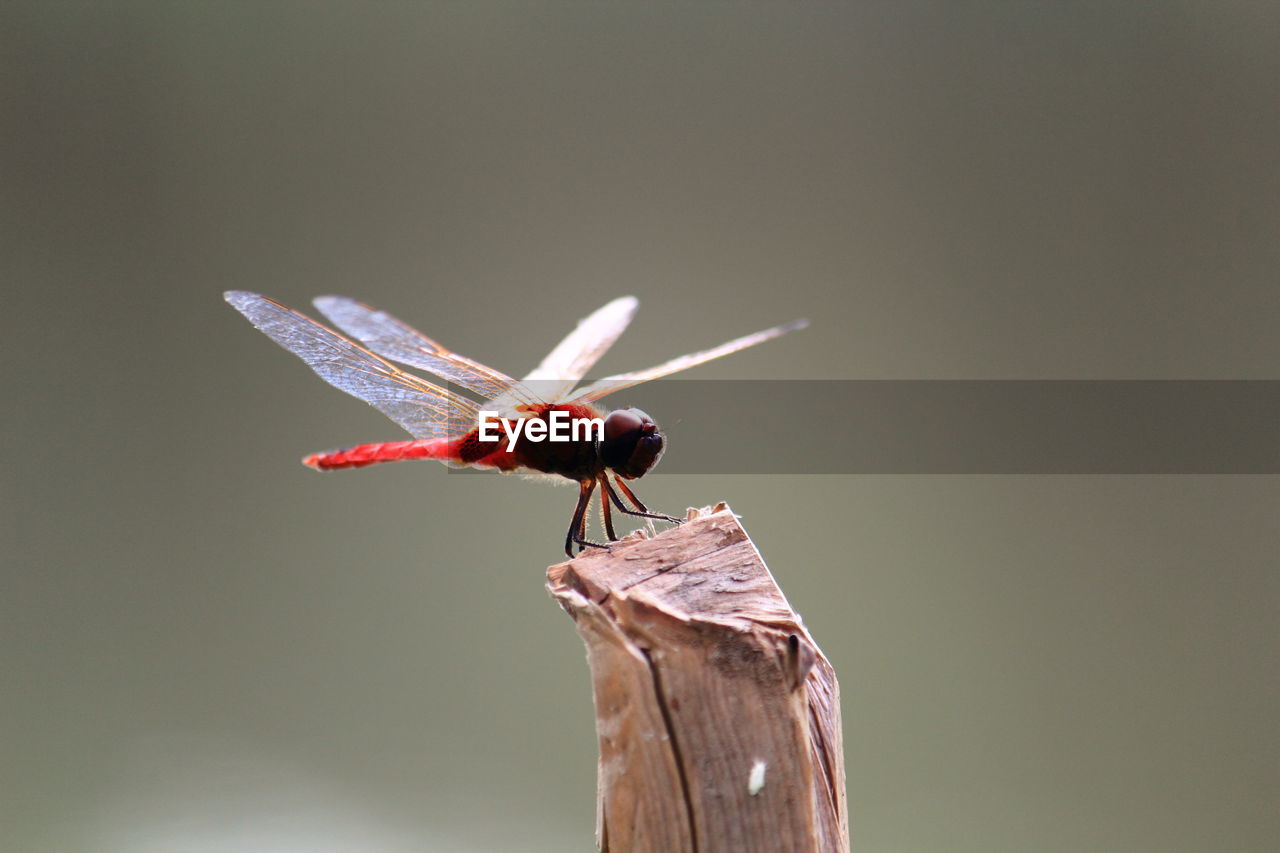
{"left": 224, "top": 291, "right": 479, "bottom": 438}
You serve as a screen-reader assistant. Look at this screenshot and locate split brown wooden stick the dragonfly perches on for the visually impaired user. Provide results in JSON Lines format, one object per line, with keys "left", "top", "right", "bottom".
{"left": 547, "top": 503, "right": 849, "bottom": 853}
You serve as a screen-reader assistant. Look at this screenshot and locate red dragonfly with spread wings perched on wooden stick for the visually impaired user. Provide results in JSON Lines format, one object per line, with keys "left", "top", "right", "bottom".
{"left": 225, "top": 291, "right": 808, "bottom": 557}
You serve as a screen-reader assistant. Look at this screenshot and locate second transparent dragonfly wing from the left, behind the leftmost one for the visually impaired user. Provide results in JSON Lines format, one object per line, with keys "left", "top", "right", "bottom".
{"left": 315, "top": 296, "right": 544, "bottom": 405}
